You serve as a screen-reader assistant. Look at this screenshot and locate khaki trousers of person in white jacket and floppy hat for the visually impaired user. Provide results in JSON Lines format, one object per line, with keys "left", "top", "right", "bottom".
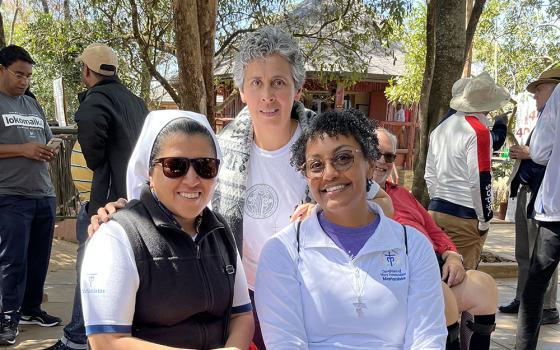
{"left": 429, "top": 210, "right": 487, "bottom": 270}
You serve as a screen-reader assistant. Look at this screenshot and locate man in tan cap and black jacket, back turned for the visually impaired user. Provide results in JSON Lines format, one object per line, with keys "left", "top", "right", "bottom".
{"left": 48, "top": 43, "right": 148, "bottom": 350}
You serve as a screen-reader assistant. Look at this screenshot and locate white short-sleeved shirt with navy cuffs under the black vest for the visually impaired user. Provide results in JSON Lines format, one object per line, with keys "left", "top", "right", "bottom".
{"left": 80, "top": 220, "right": 252, "bottom": 335}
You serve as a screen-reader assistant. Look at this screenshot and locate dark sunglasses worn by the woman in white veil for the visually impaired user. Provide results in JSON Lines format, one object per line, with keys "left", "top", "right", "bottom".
{"left": 152, "top": 157, "right": 220, "bottom": 179}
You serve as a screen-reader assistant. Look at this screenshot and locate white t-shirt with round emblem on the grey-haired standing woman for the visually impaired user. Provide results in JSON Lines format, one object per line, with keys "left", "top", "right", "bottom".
{"left": 243, "top": 125, "right": 307, "bottom": 290}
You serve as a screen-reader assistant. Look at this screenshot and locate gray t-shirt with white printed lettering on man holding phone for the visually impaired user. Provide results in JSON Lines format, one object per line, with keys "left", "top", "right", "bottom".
{"left": 0, "top": 92, "right": 55, "bottom": 198}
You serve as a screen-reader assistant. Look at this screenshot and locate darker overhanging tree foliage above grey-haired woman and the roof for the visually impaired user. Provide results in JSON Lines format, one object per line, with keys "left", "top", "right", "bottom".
{"left": 216, "top": 0, "right": 411, "bottom": 85}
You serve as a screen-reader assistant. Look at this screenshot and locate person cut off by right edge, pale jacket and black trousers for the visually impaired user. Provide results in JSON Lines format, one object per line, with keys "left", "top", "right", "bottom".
{"left": 515, "top": 70, "right": 560, "bottom": 349}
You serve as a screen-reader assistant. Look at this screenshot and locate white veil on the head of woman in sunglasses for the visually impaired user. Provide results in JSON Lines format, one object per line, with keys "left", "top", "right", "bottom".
{"left": 126, "top": 110, "right": 222, "bottom": 200}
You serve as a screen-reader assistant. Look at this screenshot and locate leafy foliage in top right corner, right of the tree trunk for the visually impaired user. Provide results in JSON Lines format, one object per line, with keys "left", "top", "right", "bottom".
{"left": 473, "top": 0, "right": 560, "bottom": 93}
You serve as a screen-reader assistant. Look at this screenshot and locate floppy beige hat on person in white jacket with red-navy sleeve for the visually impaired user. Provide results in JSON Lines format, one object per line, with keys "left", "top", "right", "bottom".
{"left": 449, "top": 72, "right": 509, "bottom": 112}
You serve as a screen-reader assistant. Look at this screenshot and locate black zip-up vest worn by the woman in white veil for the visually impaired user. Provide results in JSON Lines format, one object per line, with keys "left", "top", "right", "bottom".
{"left": 114, "top": 190, "right": 237, "bottom": 349}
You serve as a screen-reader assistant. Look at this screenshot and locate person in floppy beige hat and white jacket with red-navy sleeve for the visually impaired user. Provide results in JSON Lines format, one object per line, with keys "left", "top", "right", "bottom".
{"left": 425, "top": 72, "right": 509, "bottom": 269}
